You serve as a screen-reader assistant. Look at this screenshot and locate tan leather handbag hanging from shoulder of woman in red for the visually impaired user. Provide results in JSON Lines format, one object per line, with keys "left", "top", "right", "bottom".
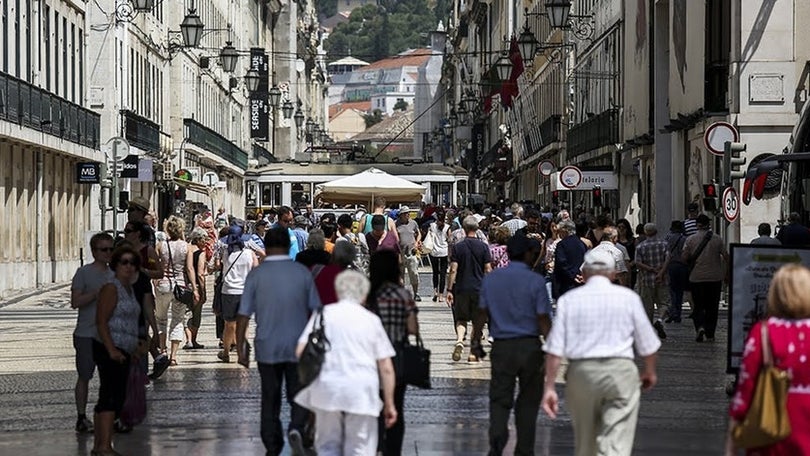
{"left": 732, "top": 321, "right": 791, "bottom": 448}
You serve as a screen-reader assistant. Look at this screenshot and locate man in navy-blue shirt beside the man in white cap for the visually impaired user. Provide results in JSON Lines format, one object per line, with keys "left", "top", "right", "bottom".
{"left": 479, "top": 233, "right": 551, "bottom": 455}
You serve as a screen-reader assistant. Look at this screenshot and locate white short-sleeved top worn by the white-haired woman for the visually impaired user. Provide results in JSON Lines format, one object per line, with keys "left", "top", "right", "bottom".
{"left": 295, "top": 301, "right": 396, "bottom": 416}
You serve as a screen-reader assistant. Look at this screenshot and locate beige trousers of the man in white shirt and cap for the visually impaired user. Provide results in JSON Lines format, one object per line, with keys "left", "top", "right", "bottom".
{"left": 565, "top": 358, "right": 641, "bottom": 456}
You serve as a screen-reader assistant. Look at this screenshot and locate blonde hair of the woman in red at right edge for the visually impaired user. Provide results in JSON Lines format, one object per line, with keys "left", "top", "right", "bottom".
{"left": 768, "top": 264, "right": 810, "bottom": 319}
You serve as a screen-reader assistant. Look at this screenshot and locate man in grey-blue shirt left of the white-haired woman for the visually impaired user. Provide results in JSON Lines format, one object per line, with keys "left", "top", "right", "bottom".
{"left": 236, "top": 228, "right": 321, "bottom": 456}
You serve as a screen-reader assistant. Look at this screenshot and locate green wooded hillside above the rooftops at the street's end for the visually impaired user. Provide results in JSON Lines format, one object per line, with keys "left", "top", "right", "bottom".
{"left": 324, "top": 0, "right": 438, "bottom": 62}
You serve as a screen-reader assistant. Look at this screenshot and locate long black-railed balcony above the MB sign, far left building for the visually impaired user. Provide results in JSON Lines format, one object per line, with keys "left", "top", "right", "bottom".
{"left": 0, "top": 72, "right": 101, "bottom": 149}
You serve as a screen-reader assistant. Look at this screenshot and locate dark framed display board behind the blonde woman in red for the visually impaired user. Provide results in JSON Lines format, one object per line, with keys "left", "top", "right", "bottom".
{"left": 726, "top": 244, "right": 810, "bottom": 374}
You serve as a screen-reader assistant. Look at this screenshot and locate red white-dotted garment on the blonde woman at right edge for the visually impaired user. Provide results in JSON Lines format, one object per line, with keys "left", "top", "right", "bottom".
{"left": 729, "top": 317, "right": 810, "bottom": 456}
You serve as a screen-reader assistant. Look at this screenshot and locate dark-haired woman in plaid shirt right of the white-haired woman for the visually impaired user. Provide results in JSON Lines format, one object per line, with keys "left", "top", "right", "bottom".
{"left": 366, "top": 250, "right": 419, "bottom": 456}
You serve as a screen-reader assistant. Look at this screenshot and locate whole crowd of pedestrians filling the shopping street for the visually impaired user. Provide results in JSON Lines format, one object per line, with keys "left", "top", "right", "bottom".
{"left": 71, "top": 194, "right": 810, "bottom": 455}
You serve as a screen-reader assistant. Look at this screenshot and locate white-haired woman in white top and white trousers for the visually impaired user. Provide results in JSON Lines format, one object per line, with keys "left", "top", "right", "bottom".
{"left": 295, "top": 270, "right": 397, "bottom": 456}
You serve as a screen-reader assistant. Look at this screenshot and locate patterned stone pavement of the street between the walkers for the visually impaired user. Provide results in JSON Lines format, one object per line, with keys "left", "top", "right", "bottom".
{"left": 0, "top": 271, "right": 729, "bottom": 456}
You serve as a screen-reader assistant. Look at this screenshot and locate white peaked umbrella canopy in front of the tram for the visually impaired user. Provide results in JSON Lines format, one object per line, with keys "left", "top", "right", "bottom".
{"left": 315, "top": 168, "right": 425, "bottom": 204}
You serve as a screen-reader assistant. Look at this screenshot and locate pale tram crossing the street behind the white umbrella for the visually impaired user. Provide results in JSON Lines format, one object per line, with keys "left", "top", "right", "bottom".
{"left": 245, "top": 162, "right": 469, "bottom": 214}
